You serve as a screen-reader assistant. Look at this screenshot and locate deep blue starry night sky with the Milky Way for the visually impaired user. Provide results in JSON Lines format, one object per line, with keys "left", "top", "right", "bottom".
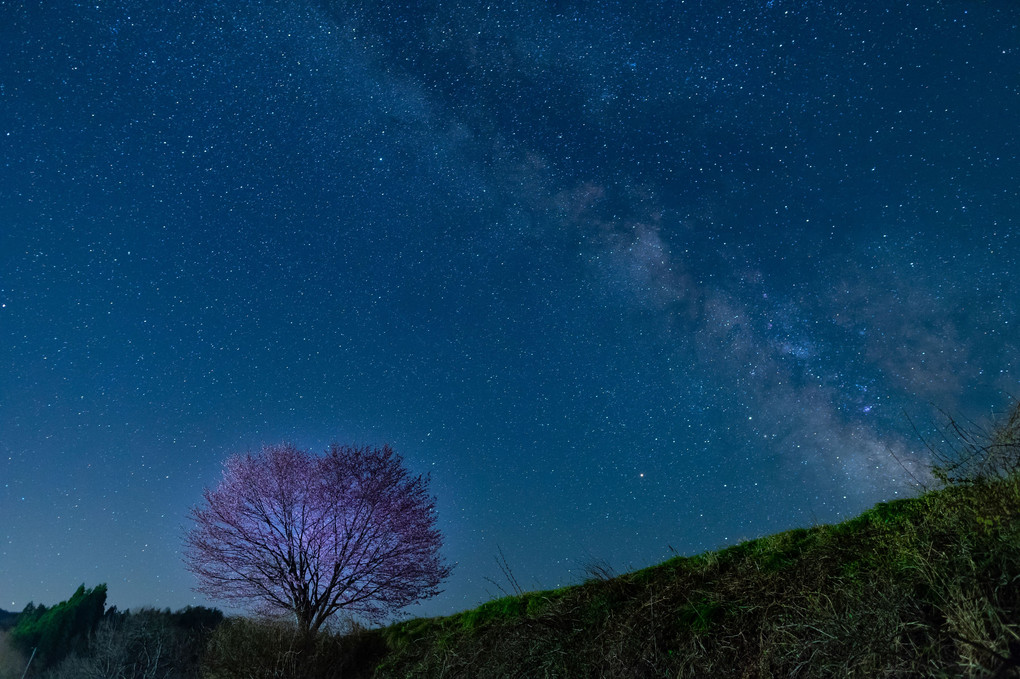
{"left": 0, "top": 0, "right": 1020, "bottom": 615}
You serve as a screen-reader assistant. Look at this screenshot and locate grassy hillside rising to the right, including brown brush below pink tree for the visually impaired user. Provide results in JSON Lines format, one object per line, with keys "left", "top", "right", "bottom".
{"left": 205, "top": 474, "right": 1020, "bottom": 679}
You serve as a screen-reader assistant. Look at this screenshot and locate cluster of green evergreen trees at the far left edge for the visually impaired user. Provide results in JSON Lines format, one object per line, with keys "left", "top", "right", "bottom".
{"left": 10, "top": 584, "right": 106, "bottom": 665}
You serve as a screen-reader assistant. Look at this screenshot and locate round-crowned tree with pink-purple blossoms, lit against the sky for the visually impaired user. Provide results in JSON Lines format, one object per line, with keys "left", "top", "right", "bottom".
{"left": 185, "top": 445, "right": 451, "bottom": 633}
